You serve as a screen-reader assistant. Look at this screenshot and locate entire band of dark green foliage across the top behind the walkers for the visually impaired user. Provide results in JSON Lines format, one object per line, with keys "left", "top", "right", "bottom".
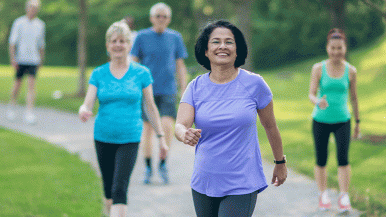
{"left": 0, "top": 0, "right": 385, "bottom": 69}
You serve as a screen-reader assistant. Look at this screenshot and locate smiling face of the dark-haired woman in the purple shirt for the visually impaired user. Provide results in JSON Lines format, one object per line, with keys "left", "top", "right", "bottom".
{"left": 205, "top": 27, "right": 237, "bottom": 66}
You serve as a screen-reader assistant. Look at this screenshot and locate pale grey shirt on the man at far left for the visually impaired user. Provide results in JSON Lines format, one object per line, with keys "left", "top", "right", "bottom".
{"left": 9, "top": 15, "right": 46, "bottom": 65}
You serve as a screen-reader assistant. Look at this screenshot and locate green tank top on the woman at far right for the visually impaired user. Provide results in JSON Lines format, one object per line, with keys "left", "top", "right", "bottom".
{"left": 312, "top": 61, "right": 351, "bottom": 124}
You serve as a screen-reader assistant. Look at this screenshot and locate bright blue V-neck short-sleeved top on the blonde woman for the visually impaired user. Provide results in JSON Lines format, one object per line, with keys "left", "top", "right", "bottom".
{"left": 89, "top": 61, "right": 153, "bottom": 144}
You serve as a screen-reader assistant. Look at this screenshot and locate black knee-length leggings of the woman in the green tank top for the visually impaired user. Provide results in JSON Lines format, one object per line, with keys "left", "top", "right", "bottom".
{"left": 312, "top": 120, "right": 351, "bottom": 167}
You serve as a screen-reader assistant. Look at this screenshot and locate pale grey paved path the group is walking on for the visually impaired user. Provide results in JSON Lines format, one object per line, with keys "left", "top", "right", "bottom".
{"left": 0, "top": 103, "right": 359, "bottom": 217}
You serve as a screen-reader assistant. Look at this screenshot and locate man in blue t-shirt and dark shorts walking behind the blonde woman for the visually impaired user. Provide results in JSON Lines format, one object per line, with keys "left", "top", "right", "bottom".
{"left": 131, "top": 3, "right": 188, "bottom": 184}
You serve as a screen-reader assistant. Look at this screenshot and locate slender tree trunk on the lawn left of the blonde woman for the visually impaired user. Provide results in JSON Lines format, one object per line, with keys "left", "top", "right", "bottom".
{"left": 77, "top": 0, "right": 87, "bottom": 97}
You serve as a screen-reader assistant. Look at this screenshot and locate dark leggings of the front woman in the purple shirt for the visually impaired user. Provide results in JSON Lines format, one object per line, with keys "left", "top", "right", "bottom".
{"left": 192, "top": 189, "right": 259, "bottom": 217}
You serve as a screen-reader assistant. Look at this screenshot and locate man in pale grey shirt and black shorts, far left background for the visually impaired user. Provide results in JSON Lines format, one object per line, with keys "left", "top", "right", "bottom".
{"left": 7, "top": 0, "right": 45, "bottom": 124}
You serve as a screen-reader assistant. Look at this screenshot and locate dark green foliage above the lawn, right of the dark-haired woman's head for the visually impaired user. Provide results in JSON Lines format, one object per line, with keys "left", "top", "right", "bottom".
{"left": 252, "top": 0, "right": 385, "bottom": 68}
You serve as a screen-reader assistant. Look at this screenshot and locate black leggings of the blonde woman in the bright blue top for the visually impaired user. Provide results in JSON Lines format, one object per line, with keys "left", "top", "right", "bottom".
{"left": 95, "top": 140, "right": 139, "bottom": 204}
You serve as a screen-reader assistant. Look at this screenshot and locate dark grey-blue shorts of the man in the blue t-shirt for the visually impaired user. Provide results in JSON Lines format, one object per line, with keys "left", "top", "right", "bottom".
{"left": 142, "top": 94, "right": 177, "bottom": 122}
